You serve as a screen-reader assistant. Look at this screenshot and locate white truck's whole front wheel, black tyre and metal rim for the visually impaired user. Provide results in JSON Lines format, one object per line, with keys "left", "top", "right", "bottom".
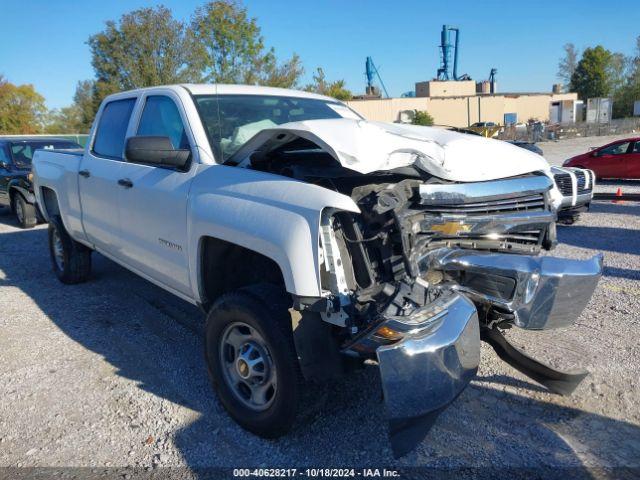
{"left": 205, "top": 285, "right": 302, "bottom": 438}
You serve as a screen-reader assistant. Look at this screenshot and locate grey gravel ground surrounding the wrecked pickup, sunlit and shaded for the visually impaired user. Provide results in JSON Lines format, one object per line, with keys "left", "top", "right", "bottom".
{"left": 0, "top": 203, "right": 640, "bottom": 477}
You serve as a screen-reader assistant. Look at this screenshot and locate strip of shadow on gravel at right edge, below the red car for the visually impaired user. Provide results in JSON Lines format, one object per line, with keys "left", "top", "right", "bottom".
{"left": 558, "top": 225, "right": 640, "bottom": 255}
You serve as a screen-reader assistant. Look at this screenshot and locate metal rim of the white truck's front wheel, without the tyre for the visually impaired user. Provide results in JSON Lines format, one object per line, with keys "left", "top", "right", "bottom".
{"left": 219, "top": 322, "right": 277, "bottom": 412}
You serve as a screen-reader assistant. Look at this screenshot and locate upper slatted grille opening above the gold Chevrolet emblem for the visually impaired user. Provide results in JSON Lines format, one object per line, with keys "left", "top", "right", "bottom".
{"left": 422, "top": 193, "right": 545, "bottom": 215}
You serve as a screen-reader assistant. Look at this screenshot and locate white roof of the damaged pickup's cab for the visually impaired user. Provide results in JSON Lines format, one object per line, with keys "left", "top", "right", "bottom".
{"left": 102, "top": 83, "right": 338, "bottom": 102}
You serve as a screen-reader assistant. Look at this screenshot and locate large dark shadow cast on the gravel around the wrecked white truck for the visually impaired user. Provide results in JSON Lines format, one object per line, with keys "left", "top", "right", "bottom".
{"left": 0, "top": 226, "right": 640, "bottom": 472}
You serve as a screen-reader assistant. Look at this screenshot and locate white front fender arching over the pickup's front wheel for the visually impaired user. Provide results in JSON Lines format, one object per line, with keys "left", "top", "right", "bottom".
{"left": 188, "top": 165, "right": 360, "bottom": 299}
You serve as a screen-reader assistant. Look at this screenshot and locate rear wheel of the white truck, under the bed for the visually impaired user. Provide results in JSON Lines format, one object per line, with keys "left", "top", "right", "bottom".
{"left": 49, "top": 216, "right": 91, "bottom": 284}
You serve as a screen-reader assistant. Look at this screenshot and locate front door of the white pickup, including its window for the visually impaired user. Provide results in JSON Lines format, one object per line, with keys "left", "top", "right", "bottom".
{"left": 118, "top": 91, "right": 197, "bottom": 296}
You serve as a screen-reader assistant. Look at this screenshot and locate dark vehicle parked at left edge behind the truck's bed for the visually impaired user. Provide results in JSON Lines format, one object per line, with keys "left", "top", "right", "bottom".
{"left": 0, "top": 136, "right": 82, "bottom": 228}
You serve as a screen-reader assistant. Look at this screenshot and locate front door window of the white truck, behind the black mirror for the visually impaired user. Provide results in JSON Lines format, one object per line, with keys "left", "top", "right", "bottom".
{"left": 137, "top": 95, "right": 189, "bottom": 149}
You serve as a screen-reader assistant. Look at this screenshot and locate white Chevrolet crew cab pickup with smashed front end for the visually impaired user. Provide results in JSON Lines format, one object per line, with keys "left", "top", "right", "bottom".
{"left": 33, "top": 85, "right": 602, "bottom": 455}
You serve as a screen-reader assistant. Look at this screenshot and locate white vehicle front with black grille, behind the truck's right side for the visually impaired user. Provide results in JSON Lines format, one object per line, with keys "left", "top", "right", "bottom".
{"left": 551, "top": 166, "right": 596, "bottom": 224}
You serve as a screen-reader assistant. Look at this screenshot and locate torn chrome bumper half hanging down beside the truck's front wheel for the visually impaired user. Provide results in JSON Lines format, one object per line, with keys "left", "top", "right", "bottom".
{"left": 376, "top": 293, "right": 480, "bottom": 457}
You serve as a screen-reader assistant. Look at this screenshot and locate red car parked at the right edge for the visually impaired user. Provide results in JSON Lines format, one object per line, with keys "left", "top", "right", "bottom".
{"left": 562, "top": 138, "right": 640, "bottom": 178}
